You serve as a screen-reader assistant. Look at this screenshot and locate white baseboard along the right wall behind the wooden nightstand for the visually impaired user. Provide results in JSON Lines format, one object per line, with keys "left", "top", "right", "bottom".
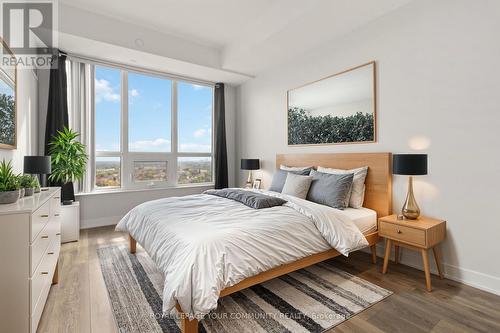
{"left": 365, "top": 243, "right": 500, "bottom": 295}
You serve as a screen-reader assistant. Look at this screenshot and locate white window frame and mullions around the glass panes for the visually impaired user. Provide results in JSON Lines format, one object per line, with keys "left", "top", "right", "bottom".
{"left": 90, "top": 61, "right": 215, "bottom": 192}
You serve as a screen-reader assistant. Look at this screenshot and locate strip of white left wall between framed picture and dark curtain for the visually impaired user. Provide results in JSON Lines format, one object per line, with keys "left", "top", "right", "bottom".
{"left": 0, "top": 69, "right": 38, "bottom": 173}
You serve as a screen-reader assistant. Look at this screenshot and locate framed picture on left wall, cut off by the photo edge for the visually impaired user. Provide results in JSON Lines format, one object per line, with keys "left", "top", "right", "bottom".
{"left": 0, "top": 37, "right": 17, "bottom": 150}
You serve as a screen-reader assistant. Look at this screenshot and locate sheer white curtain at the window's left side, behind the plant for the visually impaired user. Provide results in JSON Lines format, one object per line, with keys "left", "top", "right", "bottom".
{"left": 66, "top": 59, "right": 94, "bottom": 193}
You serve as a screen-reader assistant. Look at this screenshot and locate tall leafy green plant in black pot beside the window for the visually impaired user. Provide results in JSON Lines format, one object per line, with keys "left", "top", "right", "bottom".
{"left": 49, "top": 127, "right": 88, "bottom": 203}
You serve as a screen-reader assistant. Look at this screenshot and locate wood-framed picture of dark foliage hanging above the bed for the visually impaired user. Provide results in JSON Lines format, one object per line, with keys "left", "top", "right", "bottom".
{"left": 286, "top": 61, "right": 377, "bottom": 147}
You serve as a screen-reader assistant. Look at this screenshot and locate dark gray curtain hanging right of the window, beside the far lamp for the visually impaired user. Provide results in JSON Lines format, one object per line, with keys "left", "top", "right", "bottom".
{"left": 214, "top": 83, "right": 228, "bottom": 189}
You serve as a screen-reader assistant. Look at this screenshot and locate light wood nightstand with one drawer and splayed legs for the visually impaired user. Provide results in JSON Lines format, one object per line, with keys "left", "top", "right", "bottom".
{"left": 378, "top": 215, "right": 446, "bottom": 291}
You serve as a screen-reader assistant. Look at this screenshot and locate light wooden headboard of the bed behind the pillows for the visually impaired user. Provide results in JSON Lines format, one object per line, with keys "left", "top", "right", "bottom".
{"left": 276, "top": 153, "right": 392, "bottom": 217}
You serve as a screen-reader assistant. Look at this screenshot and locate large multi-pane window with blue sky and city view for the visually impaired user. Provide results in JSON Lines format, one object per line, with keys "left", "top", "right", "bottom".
{"left": 93, "top": 65, "right": 213, "bottom": 189}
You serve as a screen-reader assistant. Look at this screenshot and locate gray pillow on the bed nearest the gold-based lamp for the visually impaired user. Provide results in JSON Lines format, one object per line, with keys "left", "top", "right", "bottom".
{"left": 307, "top": 170, "right": 354, "bottom": 209}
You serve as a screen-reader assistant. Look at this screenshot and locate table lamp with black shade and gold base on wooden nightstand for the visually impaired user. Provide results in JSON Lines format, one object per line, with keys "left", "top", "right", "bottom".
{"left": 392, "top": 154, "right": 427, "bottom": 220}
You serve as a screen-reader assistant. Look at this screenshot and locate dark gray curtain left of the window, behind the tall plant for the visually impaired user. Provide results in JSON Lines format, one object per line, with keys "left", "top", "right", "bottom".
{"left": 45, "top": 54, "right": 68, "bottom": 155}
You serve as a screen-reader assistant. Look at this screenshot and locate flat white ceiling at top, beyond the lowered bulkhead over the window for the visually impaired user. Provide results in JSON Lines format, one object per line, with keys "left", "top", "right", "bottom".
{"left": 60, "top": 0, "right": 412, "bottom": 80}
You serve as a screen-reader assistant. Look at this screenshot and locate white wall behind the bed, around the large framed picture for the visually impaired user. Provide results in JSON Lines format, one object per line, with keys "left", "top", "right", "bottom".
{"left": 237, "top": 0, "right": 500, "bottom": 293}
